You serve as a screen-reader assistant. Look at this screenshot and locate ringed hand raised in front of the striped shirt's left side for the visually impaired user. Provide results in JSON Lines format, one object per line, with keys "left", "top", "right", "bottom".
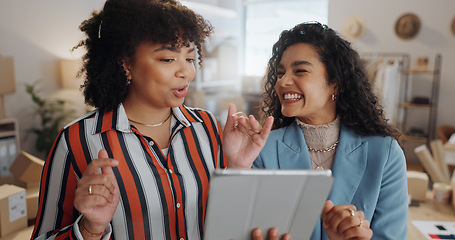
{"left": 74, "top": 149, "right": 120, "bottom": 233}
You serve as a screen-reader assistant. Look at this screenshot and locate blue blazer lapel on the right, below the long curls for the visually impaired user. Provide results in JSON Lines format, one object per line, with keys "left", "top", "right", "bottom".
{"left": 329, "top": 125, "right": 368, "bottom": 205}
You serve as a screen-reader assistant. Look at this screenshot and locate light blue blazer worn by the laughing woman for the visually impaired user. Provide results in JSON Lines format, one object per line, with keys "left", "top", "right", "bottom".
{"left": 253, "top": 122, "right": 408, "bottom": 240}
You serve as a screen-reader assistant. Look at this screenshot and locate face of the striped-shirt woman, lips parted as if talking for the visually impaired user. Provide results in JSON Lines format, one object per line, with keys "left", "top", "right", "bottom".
{"left": 123, "top": 42, "right": 196, "bottom": 109}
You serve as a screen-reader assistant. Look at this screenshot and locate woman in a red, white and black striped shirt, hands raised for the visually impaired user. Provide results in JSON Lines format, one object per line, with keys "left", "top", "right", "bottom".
{"left": 32, "top": 0, "right": 278, "bottom": 240}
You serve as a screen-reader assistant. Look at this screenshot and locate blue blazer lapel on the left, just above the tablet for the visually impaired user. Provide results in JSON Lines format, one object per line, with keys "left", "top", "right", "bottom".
{"left": 277, "top": 121, "right": 311, "bottom": 169}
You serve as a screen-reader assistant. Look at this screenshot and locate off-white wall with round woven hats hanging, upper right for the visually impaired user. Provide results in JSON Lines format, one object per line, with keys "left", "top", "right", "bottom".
{"left": 328, "top": 0, "right": 455, "bottom": 129}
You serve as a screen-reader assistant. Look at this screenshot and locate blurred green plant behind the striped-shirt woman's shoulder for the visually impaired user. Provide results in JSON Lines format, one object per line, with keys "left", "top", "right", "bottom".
{"left": 25, "top": 81, "right": 74, "bottom": 156}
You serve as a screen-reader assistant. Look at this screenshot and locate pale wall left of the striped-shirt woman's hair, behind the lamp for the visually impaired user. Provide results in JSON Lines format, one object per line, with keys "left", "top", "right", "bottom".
{"left": 0, "top": 0, "right": 104, "bottom": 158}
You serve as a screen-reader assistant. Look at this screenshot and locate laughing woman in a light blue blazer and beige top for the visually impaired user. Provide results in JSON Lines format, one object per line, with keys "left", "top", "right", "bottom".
{"left": 253, "top": 22, "right": 408, "bottom": 240}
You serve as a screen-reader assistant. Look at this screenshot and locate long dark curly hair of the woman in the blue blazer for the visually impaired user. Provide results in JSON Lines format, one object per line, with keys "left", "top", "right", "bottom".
{"left": 261, "top": 22, "right": 400, "bottom": 140}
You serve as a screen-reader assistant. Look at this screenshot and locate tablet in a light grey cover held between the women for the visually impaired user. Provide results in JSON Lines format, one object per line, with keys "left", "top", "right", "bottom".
{"left": 204, "top": 169, "right": 333, "bottom": 240}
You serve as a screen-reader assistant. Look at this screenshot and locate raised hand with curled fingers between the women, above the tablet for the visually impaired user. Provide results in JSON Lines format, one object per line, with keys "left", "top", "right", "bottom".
{"left": 223, "top": 104, "right": 273, "bottom": 168}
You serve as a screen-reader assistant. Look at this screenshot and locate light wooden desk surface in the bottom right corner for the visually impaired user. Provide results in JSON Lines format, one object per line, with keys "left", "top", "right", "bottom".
{"left": 408, "top": 192, "right": 455, "bottom": 240}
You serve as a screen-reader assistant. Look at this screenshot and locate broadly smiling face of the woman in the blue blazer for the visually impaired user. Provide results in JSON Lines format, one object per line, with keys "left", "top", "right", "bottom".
{"left": 275, "top": 43, "right": 337, "bottom": 125}
